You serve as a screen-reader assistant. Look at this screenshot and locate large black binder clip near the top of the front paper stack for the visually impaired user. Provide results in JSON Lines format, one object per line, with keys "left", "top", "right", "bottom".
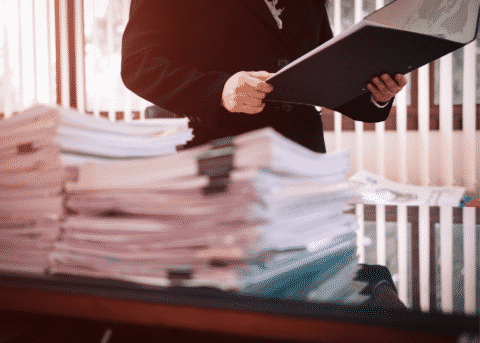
{"left": 197, "top": 137, "right": 235, "bottom": 195}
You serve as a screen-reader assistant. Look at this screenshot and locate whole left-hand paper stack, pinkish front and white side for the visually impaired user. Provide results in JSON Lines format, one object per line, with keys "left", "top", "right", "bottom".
{"left": 0, "top": 105, "right": 193, "bottom": 273}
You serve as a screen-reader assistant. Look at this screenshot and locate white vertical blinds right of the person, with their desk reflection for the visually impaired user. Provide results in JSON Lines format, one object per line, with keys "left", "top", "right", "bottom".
{"left": 326, "top": 0, "right": 480, "bottom": 313}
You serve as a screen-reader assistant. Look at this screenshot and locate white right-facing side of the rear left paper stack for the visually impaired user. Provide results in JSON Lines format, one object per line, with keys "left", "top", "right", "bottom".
{"left": 55, "top": 108, "right": 193, "bottom": 164}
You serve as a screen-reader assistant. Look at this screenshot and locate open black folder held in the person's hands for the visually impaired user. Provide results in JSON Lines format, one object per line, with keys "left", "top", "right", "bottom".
{"left": 265, "top": 0, "right": 480, "bottom": 110}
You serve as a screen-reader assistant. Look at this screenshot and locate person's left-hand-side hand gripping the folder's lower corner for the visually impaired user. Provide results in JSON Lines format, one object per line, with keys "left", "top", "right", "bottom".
{"left": 221, "top": 71, "right": 273, "bottom": 114}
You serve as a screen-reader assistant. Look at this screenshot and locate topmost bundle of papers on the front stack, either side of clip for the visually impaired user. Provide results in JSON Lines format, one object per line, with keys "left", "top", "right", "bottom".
{"left": 62, "top": 128, "right": 350, "bottom": 194}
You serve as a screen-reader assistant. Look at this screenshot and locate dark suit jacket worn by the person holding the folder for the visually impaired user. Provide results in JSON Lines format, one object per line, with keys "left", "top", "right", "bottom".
{"left": 122, "top": 0, "right": 391, "bottom": 152}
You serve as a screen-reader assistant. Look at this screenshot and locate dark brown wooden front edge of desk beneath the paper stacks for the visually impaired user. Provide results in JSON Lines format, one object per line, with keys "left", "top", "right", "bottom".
{"left": 0, "top": 272, "right": 479, "bottom": 343}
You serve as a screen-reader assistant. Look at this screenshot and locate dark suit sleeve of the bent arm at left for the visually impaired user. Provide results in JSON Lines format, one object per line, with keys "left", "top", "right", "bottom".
{"left": 121, "top": 0, "right": 231, "bottom": 130}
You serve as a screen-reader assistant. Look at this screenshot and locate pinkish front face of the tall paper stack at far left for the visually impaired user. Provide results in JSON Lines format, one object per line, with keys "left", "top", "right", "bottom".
{"left": 0, "top": 107, "right": 65, "bottom": 273}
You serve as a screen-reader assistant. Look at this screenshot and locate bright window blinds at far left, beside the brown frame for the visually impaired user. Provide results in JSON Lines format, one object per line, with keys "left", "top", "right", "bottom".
{"left": 0, "top": 0, "right": 56, "bottom": 117}
